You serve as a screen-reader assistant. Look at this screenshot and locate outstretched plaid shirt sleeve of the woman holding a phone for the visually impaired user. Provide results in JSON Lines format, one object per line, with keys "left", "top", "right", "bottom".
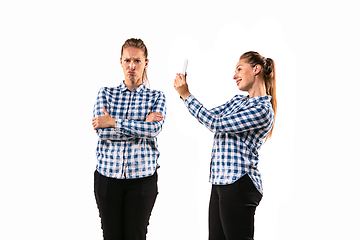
{"left": 185, "top": 95, "right": 272, "bottom": 133}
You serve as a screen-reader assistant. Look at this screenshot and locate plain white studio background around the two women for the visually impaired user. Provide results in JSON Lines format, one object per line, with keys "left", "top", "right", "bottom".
{"left": 0, "top": 1, "right": 360, "bottom": 240}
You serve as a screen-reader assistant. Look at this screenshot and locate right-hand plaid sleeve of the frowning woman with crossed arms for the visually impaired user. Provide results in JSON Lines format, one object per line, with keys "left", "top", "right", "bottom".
{"left": 115, "top": 92, "right": 166, "bottom": 138}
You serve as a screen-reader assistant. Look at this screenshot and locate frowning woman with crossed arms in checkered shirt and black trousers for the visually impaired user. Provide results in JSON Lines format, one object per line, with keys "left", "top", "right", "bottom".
{"left": 92, "top": 38, "right": 166, "bottom": 240}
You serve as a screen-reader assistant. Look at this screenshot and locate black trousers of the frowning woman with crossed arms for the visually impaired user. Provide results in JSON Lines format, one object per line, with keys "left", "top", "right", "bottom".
{"left": 94, "top": 171, "right": 158, "bottom": 240}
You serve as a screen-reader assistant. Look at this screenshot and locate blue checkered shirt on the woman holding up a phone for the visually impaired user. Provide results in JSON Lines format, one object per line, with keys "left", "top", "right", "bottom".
{"left": 184, "top": 95, "right": 274, "bottom": 193}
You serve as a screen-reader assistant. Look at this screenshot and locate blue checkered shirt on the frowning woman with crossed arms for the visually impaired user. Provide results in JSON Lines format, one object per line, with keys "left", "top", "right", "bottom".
{"left": 93, "top": 82, "right": 166, "bottom": 179}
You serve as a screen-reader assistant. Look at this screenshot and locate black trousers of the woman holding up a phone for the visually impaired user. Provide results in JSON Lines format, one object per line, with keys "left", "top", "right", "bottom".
{"left": 209, "top": 174, "right": 262, "bottom": 240}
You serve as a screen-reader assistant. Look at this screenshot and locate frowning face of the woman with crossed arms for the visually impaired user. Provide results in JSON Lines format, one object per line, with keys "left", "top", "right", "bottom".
{"left": 120, "top": 47, "right": 149, "bottom": 85}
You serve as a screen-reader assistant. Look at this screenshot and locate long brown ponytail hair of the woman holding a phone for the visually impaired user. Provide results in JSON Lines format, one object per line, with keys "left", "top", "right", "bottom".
{"left": 240, "top": 51, "right": 277, "bottom": 140}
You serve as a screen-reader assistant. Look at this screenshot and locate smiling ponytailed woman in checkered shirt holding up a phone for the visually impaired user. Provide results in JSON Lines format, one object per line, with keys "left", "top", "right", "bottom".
{"left": 174, "top": 52, "right": 277, "bottom": 240}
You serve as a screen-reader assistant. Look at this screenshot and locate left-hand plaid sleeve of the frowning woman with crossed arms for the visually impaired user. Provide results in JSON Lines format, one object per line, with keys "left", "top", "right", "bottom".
{"left": 93, "top": 88, "right": 134, "bottom": 141}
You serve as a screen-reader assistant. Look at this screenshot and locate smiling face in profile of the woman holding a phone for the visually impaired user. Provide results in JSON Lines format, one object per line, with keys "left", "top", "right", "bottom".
{"left": 234, "top": 59, "right": 257, "bottom": 91}
